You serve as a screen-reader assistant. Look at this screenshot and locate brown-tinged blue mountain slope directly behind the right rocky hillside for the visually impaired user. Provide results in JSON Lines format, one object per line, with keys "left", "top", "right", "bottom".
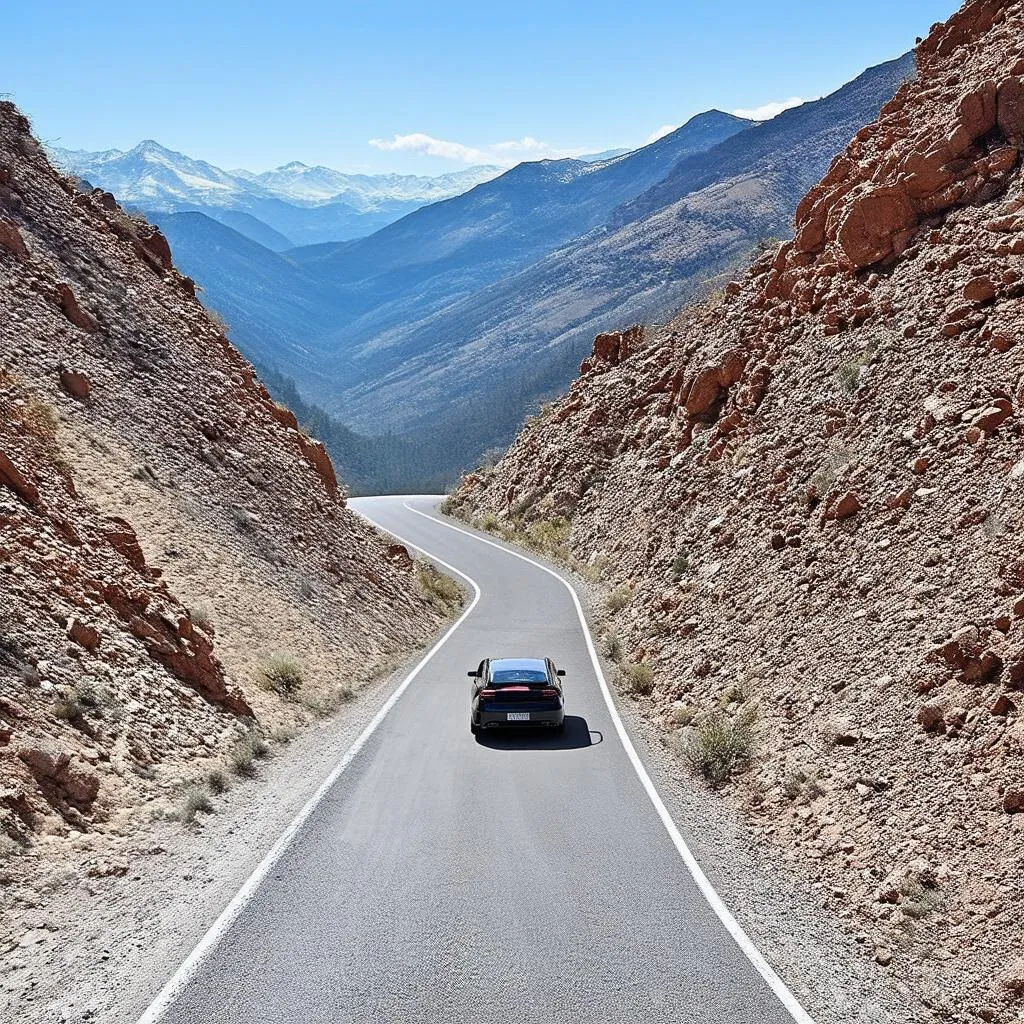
{"left": 321, "top": 54, "right": 913, "bottom": 442}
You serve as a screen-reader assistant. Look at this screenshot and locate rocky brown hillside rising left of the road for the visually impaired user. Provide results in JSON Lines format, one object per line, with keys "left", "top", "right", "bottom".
{"left": 0, "top": 103, "right": 440, "bottom": 872}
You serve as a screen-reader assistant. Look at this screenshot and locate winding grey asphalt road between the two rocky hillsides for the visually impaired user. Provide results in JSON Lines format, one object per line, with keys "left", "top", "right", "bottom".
{"left": 143, "top": 498, "right": 810, "bottom": 1024}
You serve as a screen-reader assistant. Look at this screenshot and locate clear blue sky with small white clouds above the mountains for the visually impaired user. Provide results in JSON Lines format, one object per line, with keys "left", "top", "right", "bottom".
{"left": 6, "top": 0, "right": 958, "bottom": 174}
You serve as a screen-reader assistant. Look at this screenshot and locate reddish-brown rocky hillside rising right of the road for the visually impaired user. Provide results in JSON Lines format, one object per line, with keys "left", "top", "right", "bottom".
{"left": 453, "top": 0, "right": 1024, "bottom": 1022}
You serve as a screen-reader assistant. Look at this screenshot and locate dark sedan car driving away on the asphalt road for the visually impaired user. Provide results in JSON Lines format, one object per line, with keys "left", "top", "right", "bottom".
{"left": 469, "top": 657, "right": 565, "bottom": 732}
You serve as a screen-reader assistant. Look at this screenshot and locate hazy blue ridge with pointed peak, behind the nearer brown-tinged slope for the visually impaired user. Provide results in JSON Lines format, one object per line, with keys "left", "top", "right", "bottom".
{"left": 289, "top": 111, "right": 751, "bottom": 350}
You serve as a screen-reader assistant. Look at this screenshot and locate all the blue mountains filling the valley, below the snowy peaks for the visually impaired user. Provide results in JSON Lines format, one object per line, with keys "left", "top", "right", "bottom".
{"left": 64, "top": 54, "right": 914, "bottom": 490}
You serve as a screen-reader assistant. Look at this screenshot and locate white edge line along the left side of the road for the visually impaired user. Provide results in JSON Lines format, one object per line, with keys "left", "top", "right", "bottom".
{"left": 138, "top": 528, "right": 480, "bottom": 1024}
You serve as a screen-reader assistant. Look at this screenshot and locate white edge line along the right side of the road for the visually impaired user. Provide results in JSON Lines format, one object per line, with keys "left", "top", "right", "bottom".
{"left": 395, "top": 502, "right": 814, "bottom": 1024}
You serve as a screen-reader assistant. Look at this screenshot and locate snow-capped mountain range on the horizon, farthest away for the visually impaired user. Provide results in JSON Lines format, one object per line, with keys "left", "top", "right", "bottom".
{"left": 49, "top": 139, "right": 502, "bottom": 251}
